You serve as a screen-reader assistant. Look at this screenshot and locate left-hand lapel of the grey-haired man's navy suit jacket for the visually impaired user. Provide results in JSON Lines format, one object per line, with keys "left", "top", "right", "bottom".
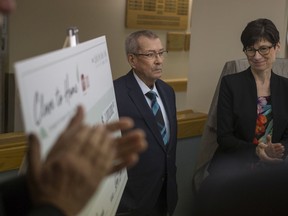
{"left": 127, "top": 71, "right": 165, "bottom": 150}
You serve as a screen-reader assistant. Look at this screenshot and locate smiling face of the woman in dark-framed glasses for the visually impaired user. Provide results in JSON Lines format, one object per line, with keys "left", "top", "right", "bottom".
{"left": 246, "top": 39, "right": 280, "bottom": 72}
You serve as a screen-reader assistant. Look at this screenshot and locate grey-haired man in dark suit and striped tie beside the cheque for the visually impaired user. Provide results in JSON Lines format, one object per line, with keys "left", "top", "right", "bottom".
{"left": 114, "top": 30, "right": 178, "bottom": 216}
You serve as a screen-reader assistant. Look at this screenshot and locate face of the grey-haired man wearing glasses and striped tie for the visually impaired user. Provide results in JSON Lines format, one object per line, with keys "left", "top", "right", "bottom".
{"left": 130, "top": 37, "right": 164, "bottom": 87}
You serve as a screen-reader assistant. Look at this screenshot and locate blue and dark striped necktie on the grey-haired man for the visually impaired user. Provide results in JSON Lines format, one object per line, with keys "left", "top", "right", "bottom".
{"left": 145, "top": 91, "right": 168, "bottom": 145}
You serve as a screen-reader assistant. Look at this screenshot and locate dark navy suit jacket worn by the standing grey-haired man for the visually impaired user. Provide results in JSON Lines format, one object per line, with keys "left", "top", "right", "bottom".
{"left": 114, "top": 71, "right": 177, "bottom": 216}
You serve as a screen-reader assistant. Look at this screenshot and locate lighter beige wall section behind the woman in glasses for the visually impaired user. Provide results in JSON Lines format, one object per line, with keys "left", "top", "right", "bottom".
{"left": 187, "top": 0, "right": 287, "bottom": 113}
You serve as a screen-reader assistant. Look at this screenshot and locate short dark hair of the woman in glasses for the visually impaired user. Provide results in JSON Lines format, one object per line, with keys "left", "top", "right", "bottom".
{"left": 241, "top": 18, "right": 280, "bottom": 49}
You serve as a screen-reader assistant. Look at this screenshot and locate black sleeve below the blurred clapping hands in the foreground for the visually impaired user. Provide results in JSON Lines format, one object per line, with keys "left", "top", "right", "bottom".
{"left": 0, "top": 176, "right": 64, "bottom": 216}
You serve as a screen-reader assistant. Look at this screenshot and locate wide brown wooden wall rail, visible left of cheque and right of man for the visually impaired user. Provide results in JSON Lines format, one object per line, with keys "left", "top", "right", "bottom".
{"left": 0, "top": 110, "right": 207, "bottom": 172}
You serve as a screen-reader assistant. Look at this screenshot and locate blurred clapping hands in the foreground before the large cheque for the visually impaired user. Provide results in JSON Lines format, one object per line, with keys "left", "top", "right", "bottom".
{"left": 27, "top": 107, "right": 147, "bottom": 215}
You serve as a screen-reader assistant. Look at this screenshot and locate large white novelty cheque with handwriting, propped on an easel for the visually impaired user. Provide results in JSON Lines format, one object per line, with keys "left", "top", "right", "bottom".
{"left": 15, "top": 36, "right": 127, "bottom": 216}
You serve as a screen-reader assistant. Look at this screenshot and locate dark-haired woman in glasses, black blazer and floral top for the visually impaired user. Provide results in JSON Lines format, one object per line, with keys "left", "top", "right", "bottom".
{"left": 208, "top": 19, "right": 288, "bottom": 175}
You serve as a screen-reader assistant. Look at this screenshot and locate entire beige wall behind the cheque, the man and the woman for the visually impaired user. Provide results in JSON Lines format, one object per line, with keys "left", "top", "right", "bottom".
{"left": 9, "top": 0, "right": 288, "bottom": 130}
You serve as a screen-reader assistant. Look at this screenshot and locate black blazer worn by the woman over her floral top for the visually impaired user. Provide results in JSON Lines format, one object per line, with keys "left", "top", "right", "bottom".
{"left": 209, "top": 67, "right": 288, "bottom": 174}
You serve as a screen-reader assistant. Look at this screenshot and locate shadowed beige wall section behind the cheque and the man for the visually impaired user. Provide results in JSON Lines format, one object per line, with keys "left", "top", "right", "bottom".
{"left": 9, "top": 0, "right": 192, "bottom": 130}
